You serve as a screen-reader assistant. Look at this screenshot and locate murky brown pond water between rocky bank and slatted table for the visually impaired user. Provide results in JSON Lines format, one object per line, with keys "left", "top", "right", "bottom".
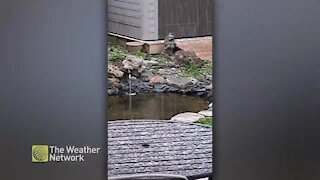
{"left": 108, "top": 93, "right": 209, "bottom": 120}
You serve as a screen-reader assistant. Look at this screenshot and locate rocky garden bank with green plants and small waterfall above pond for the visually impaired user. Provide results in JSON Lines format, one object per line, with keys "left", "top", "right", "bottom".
{"left": 108, "top": 44, "right": 212, "bottom": 101}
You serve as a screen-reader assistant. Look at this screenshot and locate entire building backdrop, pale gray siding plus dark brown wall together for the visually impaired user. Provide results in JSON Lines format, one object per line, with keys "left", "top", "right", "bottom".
{"left": 108, "top": 0, "right": 213, "bottom": 40}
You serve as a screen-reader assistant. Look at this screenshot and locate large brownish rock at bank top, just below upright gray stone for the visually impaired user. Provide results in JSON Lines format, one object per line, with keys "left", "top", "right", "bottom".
{"left": 172, "top": 50, "right": 204, "bottom": 65}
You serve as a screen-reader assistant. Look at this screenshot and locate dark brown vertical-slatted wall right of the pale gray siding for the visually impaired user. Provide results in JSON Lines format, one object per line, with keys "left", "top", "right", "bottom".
{"left": 159, "top": 0, "right": 213, "bottom": 39}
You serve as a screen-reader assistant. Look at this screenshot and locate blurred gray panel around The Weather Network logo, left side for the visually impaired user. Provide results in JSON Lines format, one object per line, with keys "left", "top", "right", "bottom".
{"left": 0, "top": 0, "right": 107, "bottom": 180}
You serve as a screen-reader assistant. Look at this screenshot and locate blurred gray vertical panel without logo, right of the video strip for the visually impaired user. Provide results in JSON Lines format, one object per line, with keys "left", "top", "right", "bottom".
{"left": 214, "top": 0, "right": 320, "bottom": 180}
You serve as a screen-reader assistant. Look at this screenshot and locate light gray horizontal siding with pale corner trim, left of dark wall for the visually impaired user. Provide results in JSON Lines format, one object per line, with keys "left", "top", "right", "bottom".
{"left": 107, "top": 0, "right": 158, "bottom": 40}
